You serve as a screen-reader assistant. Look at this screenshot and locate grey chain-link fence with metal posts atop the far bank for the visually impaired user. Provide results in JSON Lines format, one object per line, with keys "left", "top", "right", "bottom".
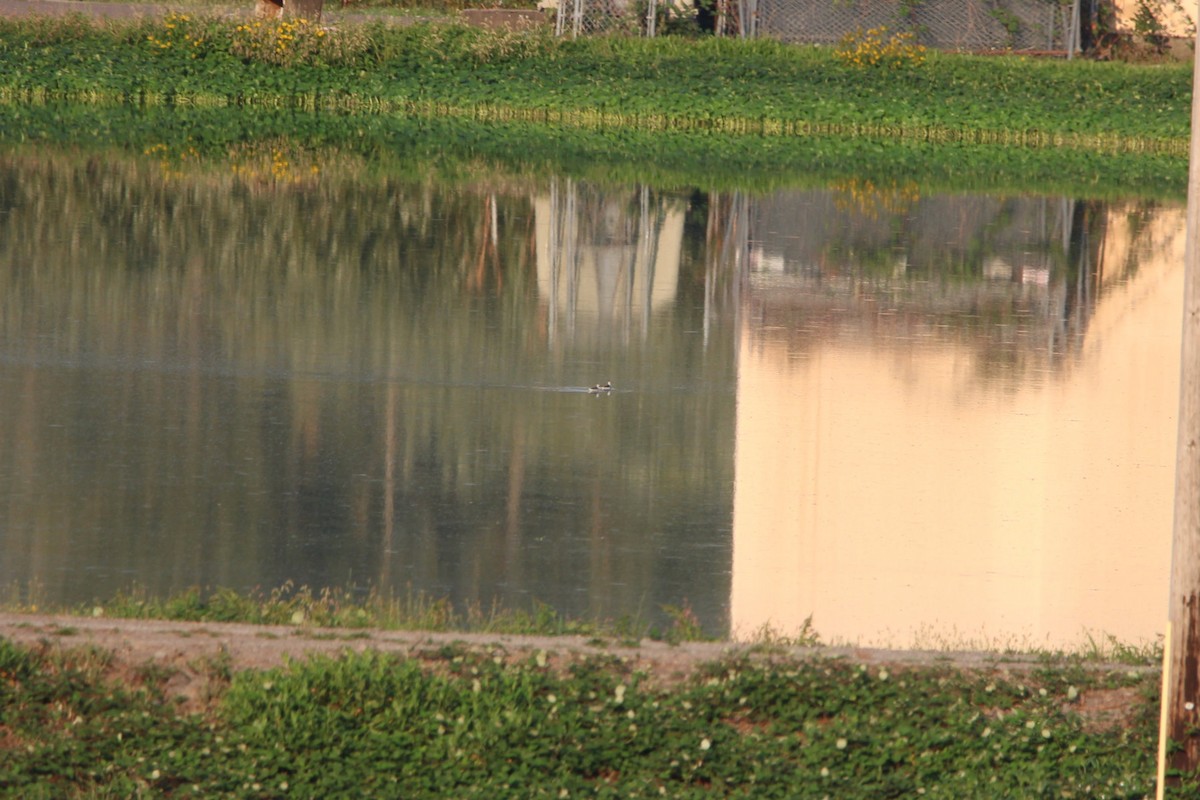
{"left": 556, "top": 0, "right": 1080, "bottom": 53}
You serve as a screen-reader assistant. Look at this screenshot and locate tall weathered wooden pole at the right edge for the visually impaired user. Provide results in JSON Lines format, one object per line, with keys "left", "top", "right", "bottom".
{"left": 1163, "top": 9, "right": 1200, "bottom": 772}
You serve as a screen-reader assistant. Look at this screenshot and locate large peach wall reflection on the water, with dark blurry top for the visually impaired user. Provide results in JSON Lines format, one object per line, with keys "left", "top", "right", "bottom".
{"left": 731, "top": 205, "right": 1184, "bottom": 645}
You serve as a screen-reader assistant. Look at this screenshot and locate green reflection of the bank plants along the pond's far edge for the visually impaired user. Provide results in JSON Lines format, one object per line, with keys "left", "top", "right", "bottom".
{"left": 0, "top": 103, "right": 1187, "bottom": 199}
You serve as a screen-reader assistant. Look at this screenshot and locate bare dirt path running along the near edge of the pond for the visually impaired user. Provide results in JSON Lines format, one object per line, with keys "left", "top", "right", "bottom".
{"left": 0, "top": 613, "right": 1154, "bottom": 728}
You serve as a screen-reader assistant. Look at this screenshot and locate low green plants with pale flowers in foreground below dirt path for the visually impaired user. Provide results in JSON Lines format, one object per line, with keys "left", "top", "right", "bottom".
{"left": 0, "top": 631, "right": 1180, "bottom": 800}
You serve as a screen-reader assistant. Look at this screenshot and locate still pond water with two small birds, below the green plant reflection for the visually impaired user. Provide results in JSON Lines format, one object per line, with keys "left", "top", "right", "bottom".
{"left": 0, "top": 156, "right": 1183, "bottom": 645}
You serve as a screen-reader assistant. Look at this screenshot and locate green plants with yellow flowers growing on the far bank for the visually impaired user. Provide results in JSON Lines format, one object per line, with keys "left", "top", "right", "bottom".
{"left": 0, "top": 14, "right": 1190, "bottom": 155}
